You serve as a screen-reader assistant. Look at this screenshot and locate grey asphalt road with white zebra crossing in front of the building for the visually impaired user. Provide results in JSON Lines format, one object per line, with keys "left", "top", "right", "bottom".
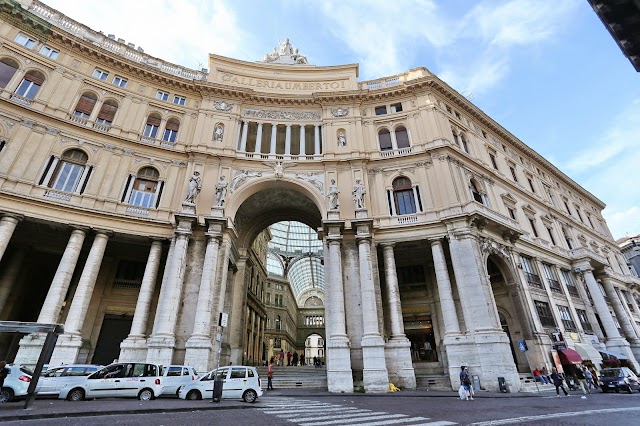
{"left": 2, "top": 392, "right": 640, "bottom": 426}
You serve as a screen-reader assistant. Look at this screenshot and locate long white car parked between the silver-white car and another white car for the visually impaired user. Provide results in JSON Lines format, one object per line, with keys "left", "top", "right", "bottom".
{"left": 58, "top": 362, "right": 163, "bottom": 401}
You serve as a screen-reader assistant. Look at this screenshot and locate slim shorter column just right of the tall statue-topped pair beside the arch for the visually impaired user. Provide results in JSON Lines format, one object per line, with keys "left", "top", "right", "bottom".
{"left": 382, "top": 243, "right": 416, "bottom": 389}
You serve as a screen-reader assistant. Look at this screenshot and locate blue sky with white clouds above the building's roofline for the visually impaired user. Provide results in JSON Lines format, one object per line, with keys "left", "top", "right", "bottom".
{"left": 45, "top": 0, "right": 640, "bottom": 238}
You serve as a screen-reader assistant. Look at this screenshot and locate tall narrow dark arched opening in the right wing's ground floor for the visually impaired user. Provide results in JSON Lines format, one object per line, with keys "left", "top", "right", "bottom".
{"left": 487, "top": 254, "right": 531, "bottom": 373}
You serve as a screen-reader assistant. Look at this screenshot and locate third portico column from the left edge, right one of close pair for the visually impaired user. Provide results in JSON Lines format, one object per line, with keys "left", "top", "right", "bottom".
{"left": 50, "top": 231, "right": 110, "bottom": 365}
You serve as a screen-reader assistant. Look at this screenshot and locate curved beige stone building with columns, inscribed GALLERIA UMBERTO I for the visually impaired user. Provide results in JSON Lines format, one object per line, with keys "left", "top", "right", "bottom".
{"left": 0, "top": 0, "right": 640, "bottom": 392}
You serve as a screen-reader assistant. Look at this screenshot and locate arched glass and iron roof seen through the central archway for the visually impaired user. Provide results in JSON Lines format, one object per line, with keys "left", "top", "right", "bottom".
{"left": 267, "top": 221, "right": 324, "bottom": 304}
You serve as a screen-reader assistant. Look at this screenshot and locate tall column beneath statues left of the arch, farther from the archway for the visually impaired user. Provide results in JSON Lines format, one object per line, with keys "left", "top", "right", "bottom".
{"left": 147, "top": 214, "right": 197, "bottom": 365}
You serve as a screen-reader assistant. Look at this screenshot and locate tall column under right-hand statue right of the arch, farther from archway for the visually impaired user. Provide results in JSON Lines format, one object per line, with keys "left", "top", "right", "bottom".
{"left": 351, "top": 219, "right": 389, "bottom": 392}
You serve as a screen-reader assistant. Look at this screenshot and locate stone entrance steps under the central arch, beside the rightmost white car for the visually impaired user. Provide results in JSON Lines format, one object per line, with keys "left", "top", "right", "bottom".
{"left": 258, "top": 365, "right": 327, "bottom": 390}
